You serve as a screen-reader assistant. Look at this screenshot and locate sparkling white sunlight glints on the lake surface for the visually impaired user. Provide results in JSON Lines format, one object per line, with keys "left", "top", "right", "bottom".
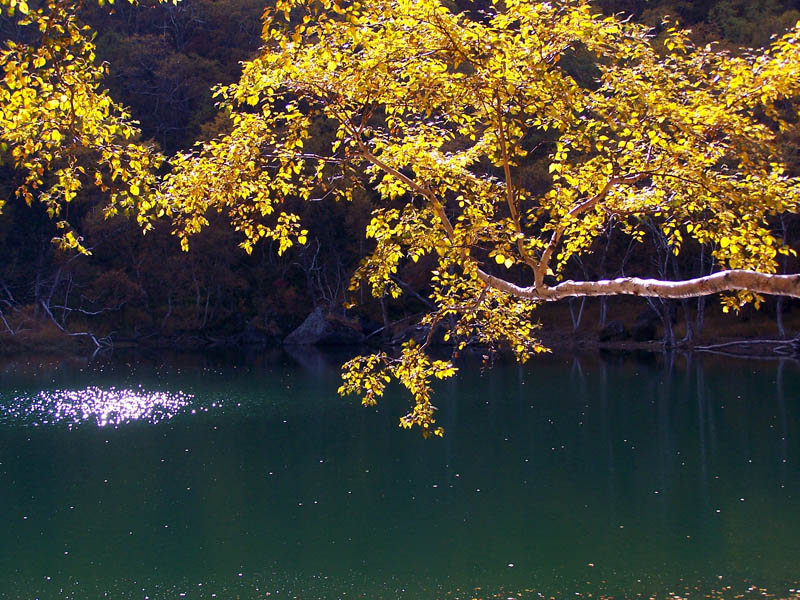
{"left": 0, "top": 386, "right": 195, "bottom": 428}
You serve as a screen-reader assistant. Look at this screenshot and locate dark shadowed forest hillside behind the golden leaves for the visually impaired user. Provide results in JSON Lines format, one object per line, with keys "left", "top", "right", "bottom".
{"left": 0, "top": 0, "right": 800, "bottom": 352}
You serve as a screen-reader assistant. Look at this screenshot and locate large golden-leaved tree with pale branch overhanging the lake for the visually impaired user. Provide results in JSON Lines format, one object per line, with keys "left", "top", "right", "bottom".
{"left": 0, "top": 0, "right": 800, "bottom": 434}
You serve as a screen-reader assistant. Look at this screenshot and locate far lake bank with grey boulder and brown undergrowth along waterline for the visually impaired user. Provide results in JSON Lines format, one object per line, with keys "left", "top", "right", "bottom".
{"left": 0, "top": 298, "right": 800, "bottom": 358}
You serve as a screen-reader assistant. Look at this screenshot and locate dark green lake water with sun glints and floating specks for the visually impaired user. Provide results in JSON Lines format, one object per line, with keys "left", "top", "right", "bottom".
{"left": 0, "top": 350, "right": 800, "bottom": 600}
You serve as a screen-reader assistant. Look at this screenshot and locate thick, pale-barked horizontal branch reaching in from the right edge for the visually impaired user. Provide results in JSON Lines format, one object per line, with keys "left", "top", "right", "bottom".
{"left": 478, "top": 269, "right": 800, "bottom": 301}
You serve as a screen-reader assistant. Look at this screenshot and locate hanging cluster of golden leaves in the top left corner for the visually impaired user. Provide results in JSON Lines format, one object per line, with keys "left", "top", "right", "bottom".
{"left": 0, "top": 0, "right": 170, "bottom": 251}
